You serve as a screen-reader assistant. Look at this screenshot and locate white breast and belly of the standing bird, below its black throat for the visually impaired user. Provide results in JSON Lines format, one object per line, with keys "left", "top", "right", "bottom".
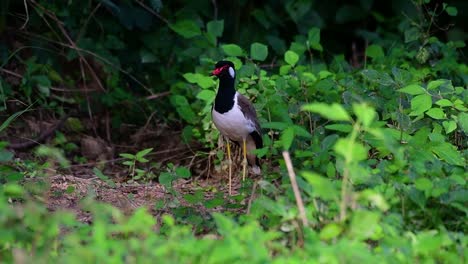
{"left": 212, "top": 92, "right": 255, "bottom": 141}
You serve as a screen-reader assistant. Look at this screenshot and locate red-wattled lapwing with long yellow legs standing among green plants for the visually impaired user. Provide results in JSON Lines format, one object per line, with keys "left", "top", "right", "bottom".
{"left": 211, "top": 61, "right": 263, "bottom": 194}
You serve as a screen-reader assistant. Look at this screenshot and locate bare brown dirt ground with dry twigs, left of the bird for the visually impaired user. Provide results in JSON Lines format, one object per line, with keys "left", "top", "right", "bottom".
{"left": 0, "top": 115, "right": 249, "bottom": 223}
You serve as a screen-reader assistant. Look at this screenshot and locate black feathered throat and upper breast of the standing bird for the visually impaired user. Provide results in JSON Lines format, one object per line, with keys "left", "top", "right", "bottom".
{"left": 214, "top": 74, "right": 236, "bottom": 114}
